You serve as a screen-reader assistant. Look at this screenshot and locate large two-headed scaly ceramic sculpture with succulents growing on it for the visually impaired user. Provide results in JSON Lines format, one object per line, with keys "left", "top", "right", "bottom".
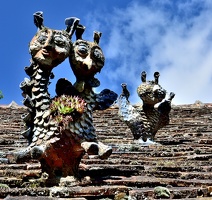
{"left": 16, "top": 12, "right": 117, "bottom": 183}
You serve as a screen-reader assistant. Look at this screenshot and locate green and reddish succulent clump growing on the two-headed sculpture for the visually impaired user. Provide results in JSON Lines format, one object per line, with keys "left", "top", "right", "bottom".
{"left": 50, "top": 95, "right": 86, "bottom": 128}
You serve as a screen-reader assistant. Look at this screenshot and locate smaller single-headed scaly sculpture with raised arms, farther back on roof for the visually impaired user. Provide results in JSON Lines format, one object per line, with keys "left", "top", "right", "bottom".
{"left": 118, "top": 71, "right": 175, "bottom": 142}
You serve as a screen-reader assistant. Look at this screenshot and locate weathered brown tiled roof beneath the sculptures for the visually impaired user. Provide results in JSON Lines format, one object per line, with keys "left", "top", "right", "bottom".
{"left": 0, "top": 104, "right": 212, "bottom": 200}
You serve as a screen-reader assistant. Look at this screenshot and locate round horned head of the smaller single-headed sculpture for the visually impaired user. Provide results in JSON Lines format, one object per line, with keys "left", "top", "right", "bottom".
{"left": 137, "top": 72, "right": 166, "bottom": 106}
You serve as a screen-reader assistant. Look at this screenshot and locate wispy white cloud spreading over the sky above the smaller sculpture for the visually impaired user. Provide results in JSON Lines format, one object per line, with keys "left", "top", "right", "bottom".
{"left": 85, "top": 0, "right": 212, "bottom": 104}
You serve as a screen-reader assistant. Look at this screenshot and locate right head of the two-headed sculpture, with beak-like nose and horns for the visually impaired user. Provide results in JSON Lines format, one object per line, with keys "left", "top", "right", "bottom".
{"left": 69, "top": 26, "right": 105, "bottom": 81}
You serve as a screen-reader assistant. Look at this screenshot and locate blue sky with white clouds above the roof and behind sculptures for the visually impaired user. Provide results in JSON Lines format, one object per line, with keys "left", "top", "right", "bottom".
{"left": 0, "top": 0, "right": 212, "bottom": 105}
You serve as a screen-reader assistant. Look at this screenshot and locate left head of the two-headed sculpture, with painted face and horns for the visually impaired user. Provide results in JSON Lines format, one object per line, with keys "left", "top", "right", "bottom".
{"left": 29, "top": 11, "right": 79, "bottom": 69}
